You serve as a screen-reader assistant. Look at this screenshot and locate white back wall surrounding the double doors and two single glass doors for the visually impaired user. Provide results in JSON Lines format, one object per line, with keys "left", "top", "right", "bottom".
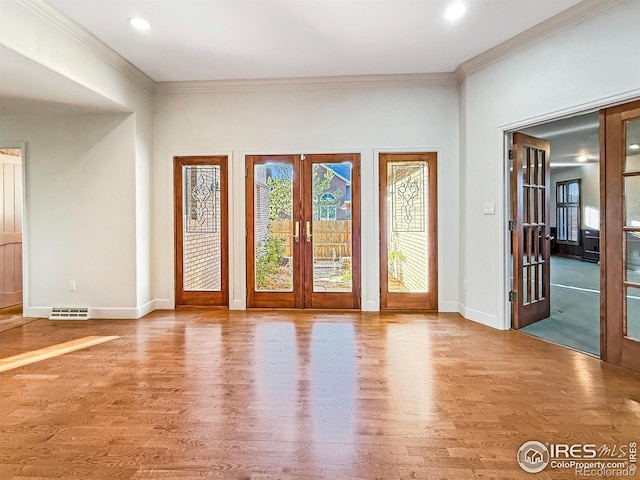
{"left": 152, "top": 84, "right": 459, "bottom": 311}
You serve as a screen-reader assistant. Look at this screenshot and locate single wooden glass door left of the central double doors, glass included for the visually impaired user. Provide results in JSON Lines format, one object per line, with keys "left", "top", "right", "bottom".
{"left": 173, "top": 156, "right": 229, "bottom": 307}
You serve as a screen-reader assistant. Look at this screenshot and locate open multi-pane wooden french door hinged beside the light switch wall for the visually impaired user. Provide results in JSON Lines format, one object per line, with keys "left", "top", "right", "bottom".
{"left": 510, "top": 133, "right": 551, "bottom": 328}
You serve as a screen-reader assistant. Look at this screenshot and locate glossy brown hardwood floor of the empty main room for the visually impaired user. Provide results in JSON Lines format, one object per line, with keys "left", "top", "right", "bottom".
{"left": 0, "top": 310, "right": 640, "bottom": 480}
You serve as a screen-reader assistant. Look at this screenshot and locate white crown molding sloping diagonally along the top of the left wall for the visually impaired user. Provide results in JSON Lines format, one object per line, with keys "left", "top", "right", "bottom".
{"left": 16, "top": 0, "right": 155, "bottom": 92}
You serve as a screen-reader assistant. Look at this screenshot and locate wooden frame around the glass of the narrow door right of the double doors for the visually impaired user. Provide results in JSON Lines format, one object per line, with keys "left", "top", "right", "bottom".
{"left": 378, "top": 152, "right": 438, "bottom": 311}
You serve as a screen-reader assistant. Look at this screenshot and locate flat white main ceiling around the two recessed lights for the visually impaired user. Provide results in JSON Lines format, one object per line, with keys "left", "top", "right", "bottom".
{"left": 49, "top": 0, "right": 580, "bottom": 81}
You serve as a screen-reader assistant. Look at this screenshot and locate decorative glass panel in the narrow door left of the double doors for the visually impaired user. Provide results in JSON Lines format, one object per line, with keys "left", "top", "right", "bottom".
{"left": 182, "top": 165, "right": 221, "bottom": 292}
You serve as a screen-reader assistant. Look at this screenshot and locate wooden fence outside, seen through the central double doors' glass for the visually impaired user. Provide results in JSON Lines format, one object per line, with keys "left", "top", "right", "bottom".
{"left": 269, "top": 220, "right": 351, "bottom": 260}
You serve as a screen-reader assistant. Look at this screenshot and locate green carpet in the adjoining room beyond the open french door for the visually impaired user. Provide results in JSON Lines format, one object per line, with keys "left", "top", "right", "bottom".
{"left": 522, "top": 257, "right": 600, "bottom": 356}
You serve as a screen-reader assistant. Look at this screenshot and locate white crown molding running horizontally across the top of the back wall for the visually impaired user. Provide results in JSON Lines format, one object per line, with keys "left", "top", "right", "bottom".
{"left": 155, "top": 72, "right": 458, "bottom": 94}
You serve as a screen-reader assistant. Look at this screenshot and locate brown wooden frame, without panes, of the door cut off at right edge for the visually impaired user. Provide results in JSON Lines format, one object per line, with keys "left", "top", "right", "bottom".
{"left": 600, "top": 100, "right": 640, "bottom": 371}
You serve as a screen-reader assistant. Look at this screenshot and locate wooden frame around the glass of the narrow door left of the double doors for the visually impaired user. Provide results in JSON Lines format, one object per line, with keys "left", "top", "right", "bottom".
{"left": 173, "top": 155, "right": 229, "bottom": 308}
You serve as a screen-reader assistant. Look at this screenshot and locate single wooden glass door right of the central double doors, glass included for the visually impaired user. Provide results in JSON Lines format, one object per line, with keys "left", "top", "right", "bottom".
{"left": 379, "top": 152, "right": 438, "bottom": 310}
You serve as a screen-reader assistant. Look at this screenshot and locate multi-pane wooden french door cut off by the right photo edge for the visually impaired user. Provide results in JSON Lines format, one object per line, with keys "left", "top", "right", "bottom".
{"left": 600, "top": 102, "right": 640, "bottom": 371}
